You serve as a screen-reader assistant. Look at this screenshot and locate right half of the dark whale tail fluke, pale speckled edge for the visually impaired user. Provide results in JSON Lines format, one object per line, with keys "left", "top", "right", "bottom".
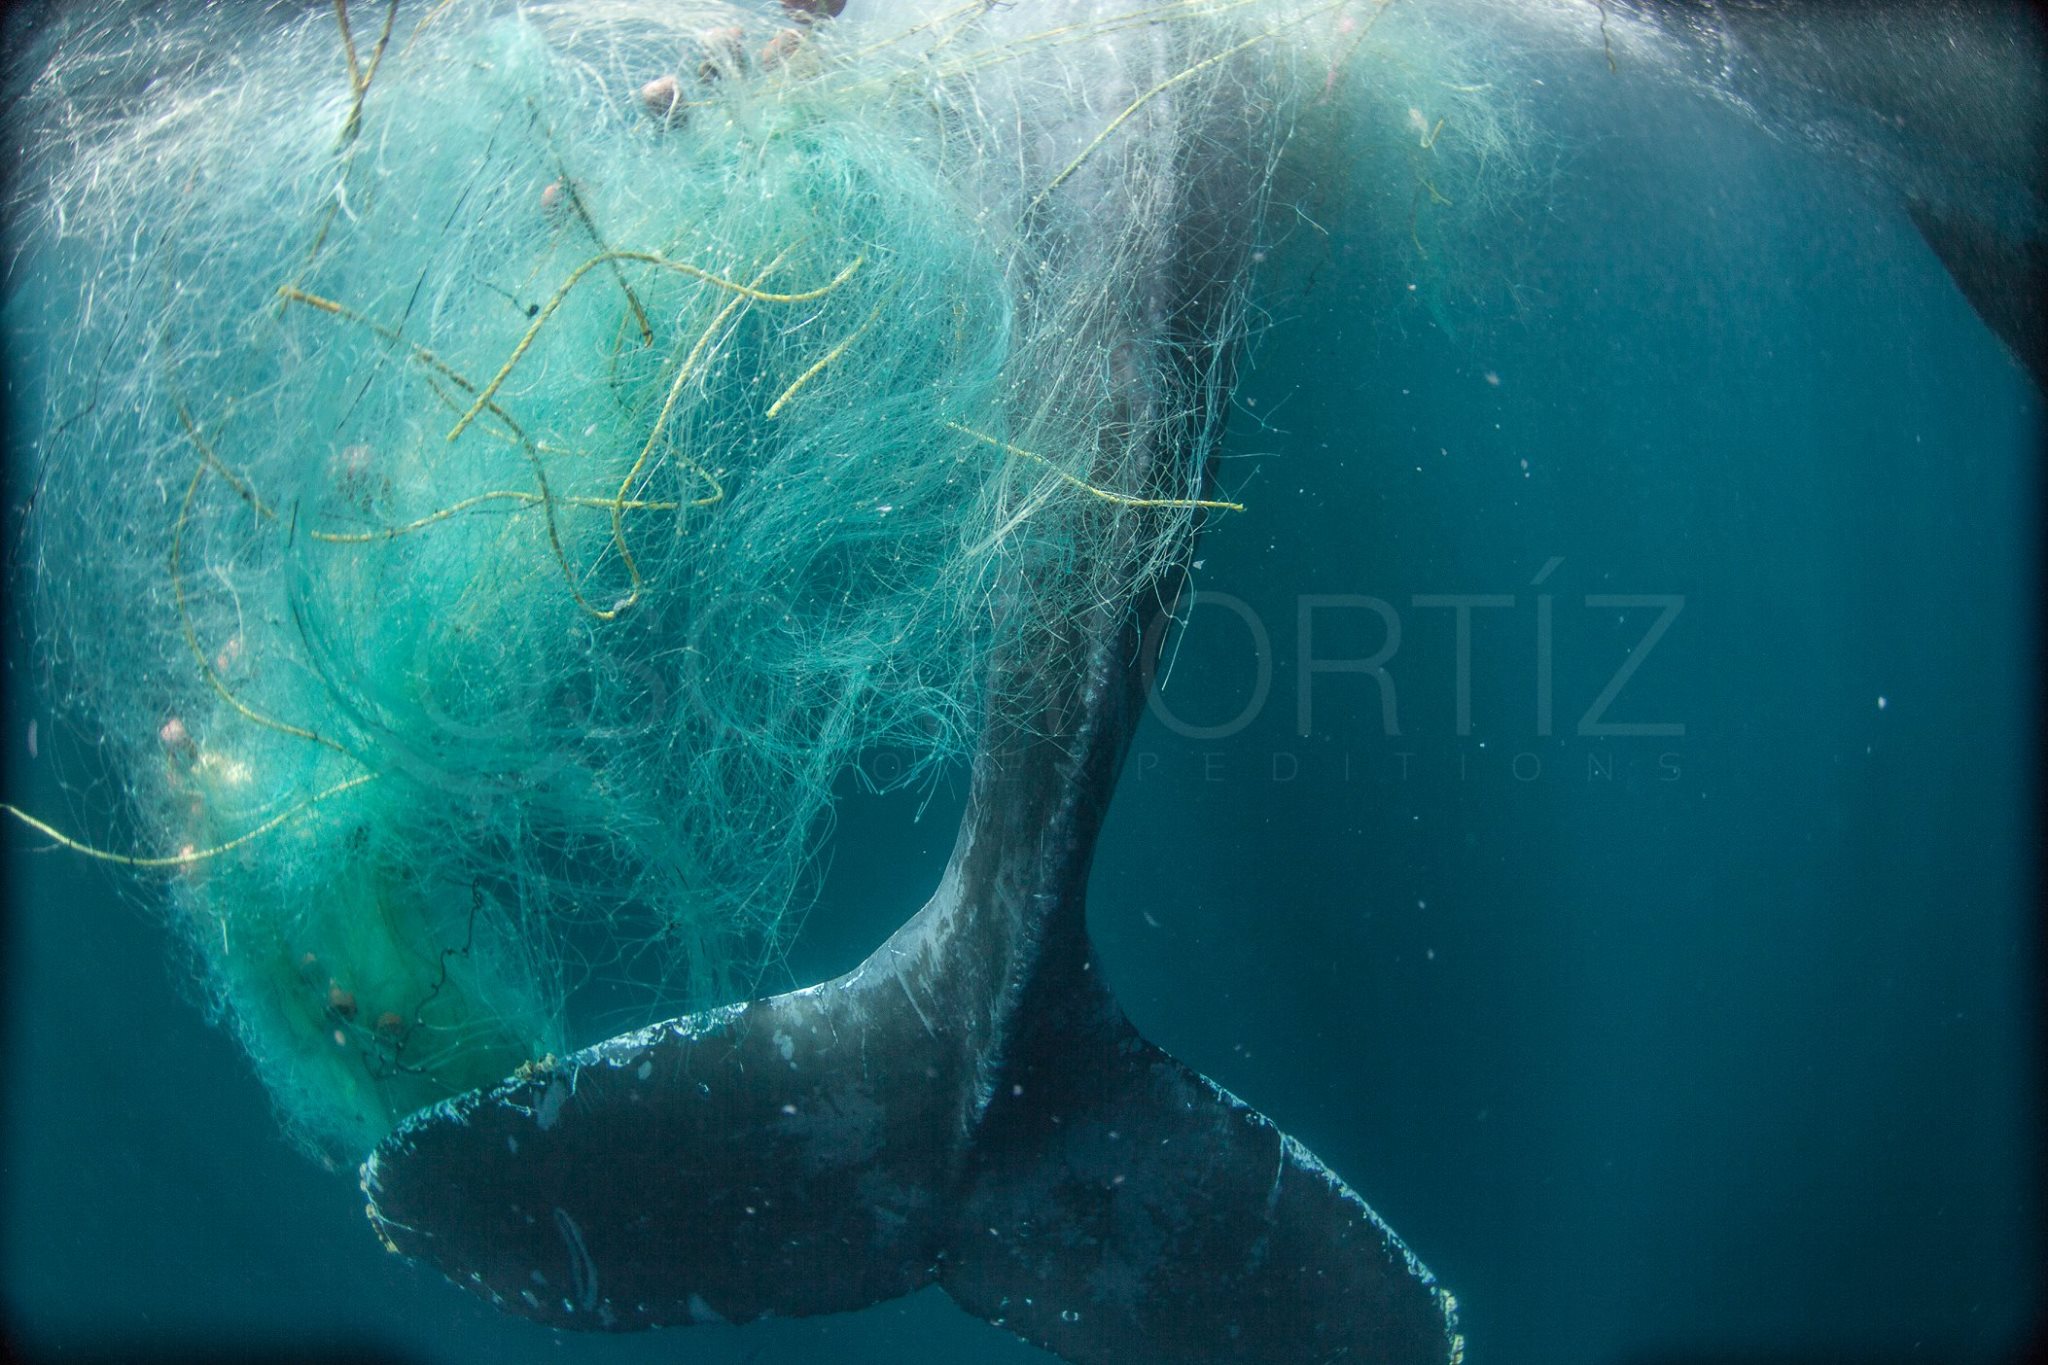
{"left": 938, "top": 961, "right": 1464, "bottom": 1365}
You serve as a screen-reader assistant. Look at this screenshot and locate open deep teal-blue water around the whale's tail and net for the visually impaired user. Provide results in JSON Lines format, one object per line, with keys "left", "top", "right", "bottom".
{"left": 0, "top": 5, "right": 2042, "bottom": 1365}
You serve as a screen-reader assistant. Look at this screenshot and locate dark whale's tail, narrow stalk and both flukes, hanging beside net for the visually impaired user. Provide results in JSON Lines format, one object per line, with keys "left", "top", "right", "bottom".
{"left": 362, "top": 4, "right": 1464, "bottom": 1365}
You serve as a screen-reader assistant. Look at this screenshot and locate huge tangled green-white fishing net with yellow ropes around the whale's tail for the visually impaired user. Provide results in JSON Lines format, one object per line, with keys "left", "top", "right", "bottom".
{"left": 8, "top": 0, "right": 1507, "bottom": 1158}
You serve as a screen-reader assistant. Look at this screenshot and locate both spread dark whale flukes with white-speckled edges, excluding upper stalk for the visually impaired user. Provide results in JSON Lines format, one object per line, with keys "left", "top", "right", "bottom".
{"left": 365, "top": 880, "right": 1462, "bottom": 1365}
